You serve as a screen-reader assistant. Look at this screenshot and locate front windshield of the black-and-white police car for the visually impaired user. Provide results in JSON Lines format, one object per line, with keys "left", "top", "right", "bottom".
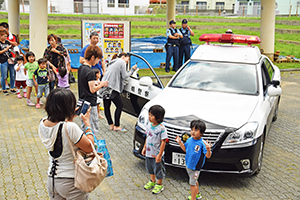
{"left": 170, "top": 61, "right": 257, "bottom": 94}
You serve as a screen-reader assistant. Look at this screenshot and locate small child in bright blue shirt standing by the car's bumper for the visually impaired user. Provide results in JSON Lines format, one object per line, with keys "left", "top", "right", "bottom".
{"left": 176, "top": 120, "right": 212, "bottom": 200}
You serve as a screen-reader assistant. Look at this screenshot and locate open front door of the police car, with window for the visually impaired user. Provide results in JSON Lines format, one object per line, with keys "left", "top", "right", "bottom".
{"left": 121, "top": 53, "right": 164, "bottom": 117}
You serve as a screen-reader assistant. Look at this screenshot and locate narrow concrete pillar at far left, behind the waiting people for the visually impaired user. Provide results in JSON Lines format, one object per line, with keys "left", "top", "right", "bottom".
{"left": 8, "top": 0, "right": 20, "bottom": 36}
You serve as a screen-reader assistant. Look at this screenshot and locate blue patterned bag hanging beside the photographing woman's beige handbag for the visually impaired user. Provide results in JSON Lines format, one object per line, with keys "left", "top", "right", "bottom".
{"left": 94, "top": 135, "right": 114, "bottom": 177}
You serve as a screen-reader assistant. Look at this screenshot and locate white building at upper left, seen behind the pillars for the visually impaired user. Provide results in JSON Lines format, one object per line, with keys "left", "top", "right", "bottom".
{"left": 3, "top": 0, "right": 149, "bottom": 15}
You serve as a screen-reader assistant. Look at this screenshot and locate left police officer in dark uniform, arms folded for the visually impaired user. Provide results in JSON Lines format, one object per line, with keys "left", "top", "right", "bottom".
{"left": 165, "top": 20, "right": 182, "bottom": 72}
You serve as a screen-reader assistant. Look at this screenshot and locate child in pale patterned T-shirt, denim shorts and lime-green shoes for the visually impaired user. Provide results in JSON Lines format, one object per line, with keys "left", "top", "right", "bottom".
{"left": 142, "top": 105, "right": 168, "bottom": 194}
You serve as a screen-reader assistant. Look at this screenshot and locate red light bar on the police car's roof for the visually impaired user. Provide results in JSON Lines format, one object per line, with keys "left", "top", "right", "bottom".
{"left": 199, "top": 34, "right": 261, "bottom": 44}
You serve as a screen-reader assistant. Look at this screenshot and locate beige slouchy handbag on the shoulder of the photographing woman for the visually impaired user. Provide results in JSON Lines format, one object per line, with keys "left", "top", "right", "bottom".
{"left": 65, "top": 123, "right": 107, "bottom": 192}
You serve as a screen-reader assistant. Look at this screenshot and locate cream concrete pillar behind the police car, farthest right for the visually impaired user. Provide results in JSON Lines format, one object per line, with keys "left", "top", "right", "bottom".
{"left": 260, "top": 0, "right": 275, "bottom": 61}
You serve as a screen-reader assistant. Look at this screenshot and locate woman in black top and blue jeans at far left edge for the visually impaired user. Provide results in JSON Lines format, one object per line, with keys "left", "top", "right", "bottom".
{"left": 0, "top": 29, "right": 15, "bottom": 95}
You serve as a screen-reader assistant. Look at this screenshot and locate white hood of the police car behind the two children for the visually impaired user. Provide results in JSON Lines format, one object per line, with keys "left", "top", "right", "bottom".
{"left": 146, "top": 87, "right": 258, "bottom": 128}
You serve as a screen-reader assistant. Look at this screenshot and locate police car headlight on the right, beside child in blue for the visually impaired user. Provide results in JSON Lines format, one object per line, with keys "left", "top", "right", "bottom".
{"left": 221, "top": 122, "right": 258, "bottom": 148}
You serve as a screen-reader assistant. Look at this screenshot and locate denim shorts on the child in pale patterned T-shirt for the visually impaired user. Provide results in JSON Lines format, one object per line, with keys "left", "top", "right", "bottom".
{"left": 145, "top": 157, "right": 166, "bottom": 179}
